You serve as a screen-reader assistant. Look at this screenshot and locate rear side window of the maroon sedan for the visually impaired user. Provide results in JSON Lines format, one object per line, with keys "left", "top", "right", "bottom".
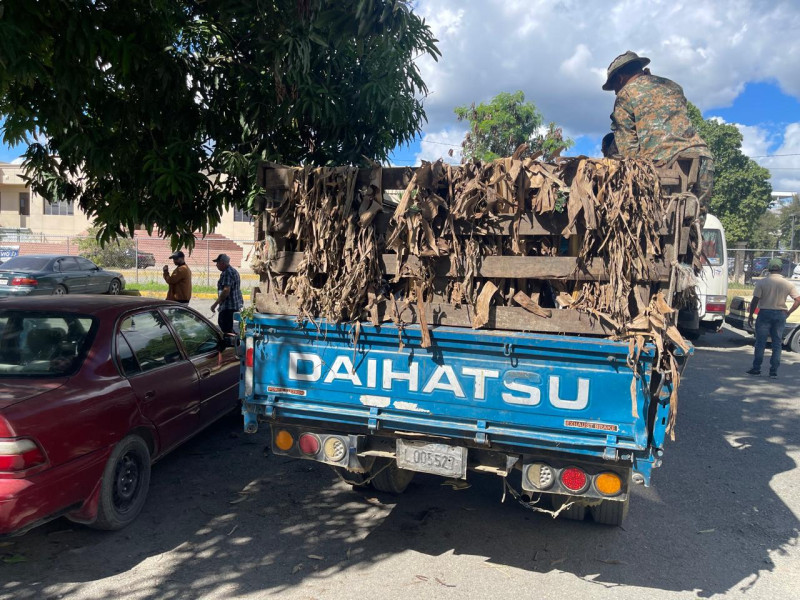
{"left": 119, "top": 310, "right": 182, "bottom": 372}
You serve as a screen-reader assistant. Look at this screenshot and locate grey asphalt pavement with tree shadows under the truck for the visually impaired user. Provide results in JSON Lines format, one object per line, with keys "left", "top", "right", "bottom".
{"left": 0, "top": 326, "right": 800, "bottom": 600}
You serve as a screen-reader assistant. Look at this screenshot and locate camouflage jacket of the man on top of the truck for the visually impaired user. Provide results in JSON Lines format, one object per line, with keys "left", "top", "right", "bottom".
{"left": 611, "top": 74, "right": 711, "bottom": 165}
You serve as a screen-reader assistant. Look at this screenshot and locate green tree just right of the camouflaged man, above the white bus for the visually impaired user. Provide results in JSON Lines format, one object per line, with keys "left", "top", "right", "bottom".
{"left": 689, "top": 103, "right": 772, "bottom": 245}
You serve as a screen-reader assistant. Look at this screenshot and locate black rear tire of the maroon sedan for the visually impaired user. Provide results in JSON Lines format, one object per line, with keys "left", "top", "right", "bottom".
{"left": 92, "top": 435, "right": 150, "bottom": 530}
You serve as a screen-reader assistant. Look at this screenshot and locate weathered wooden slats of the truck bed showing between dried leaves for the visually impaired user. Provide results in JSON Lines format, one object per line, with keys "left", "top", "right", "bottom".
{"left": 254, "top": 158, "right": 699, "bottom": 335}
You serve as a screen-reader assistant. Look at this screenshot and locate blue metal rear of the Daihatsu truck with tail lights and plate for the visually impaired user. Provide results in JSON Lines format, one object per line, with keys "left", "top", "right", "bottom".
{"left": 240, "top": 163, "right": 691, "bottom": 525}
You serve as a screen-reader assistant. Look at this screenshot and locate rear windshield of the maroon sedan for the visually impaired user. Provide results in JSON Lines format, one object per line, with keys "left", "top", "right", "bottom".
{"left": 0, "top": 310, "right": 96, "bottom": 378}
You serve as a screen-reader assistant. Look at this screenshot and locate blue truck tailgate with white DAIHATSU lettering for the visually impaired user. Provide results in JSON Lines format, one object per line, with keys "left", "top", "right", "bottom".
{"left": 248, "top": 314, "right": 654, "bottom": 450}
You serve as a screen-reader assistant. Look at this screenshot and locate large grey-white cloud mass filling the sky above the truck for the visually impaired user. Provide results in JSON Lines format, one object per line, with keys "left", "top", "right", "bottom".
{"left": 416, "top": 0, "right": 800, "bottom": 136}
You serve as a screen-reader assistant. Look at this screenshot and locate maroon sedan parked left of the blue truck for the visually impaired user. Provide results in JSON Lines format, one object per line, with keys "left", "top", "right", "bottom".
{"left": 0, "top": 296, "right": 239, "bottom": 536}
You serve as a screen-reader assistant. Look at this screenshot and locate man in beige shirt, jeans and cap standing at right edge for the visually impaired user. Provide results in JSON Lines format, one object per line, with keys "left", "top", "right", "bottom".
{"left": 747, "top": 258, "right": 800, "bottom": 377}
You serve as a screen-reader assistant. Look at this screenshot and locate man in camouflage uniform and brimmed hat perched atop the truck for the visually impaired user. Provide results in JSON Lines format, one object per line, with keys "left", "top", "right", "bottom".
{"left": 603, "top": 50, "right": 714, "bottom": 206}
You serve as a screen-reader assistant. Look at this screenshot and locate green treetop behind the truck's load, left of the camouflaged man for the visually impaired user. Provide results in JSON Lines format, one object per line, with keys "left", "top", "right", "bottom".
{"left": 455, "top": 91, "right": 574, "bottom": 161}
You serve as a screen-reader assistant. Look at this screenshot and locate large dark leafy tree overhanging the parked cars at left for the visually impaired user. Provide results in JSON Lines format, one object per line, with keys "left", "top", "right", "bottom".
{"left": 0, "top": 0, "right": 439, "bottom": 247}
